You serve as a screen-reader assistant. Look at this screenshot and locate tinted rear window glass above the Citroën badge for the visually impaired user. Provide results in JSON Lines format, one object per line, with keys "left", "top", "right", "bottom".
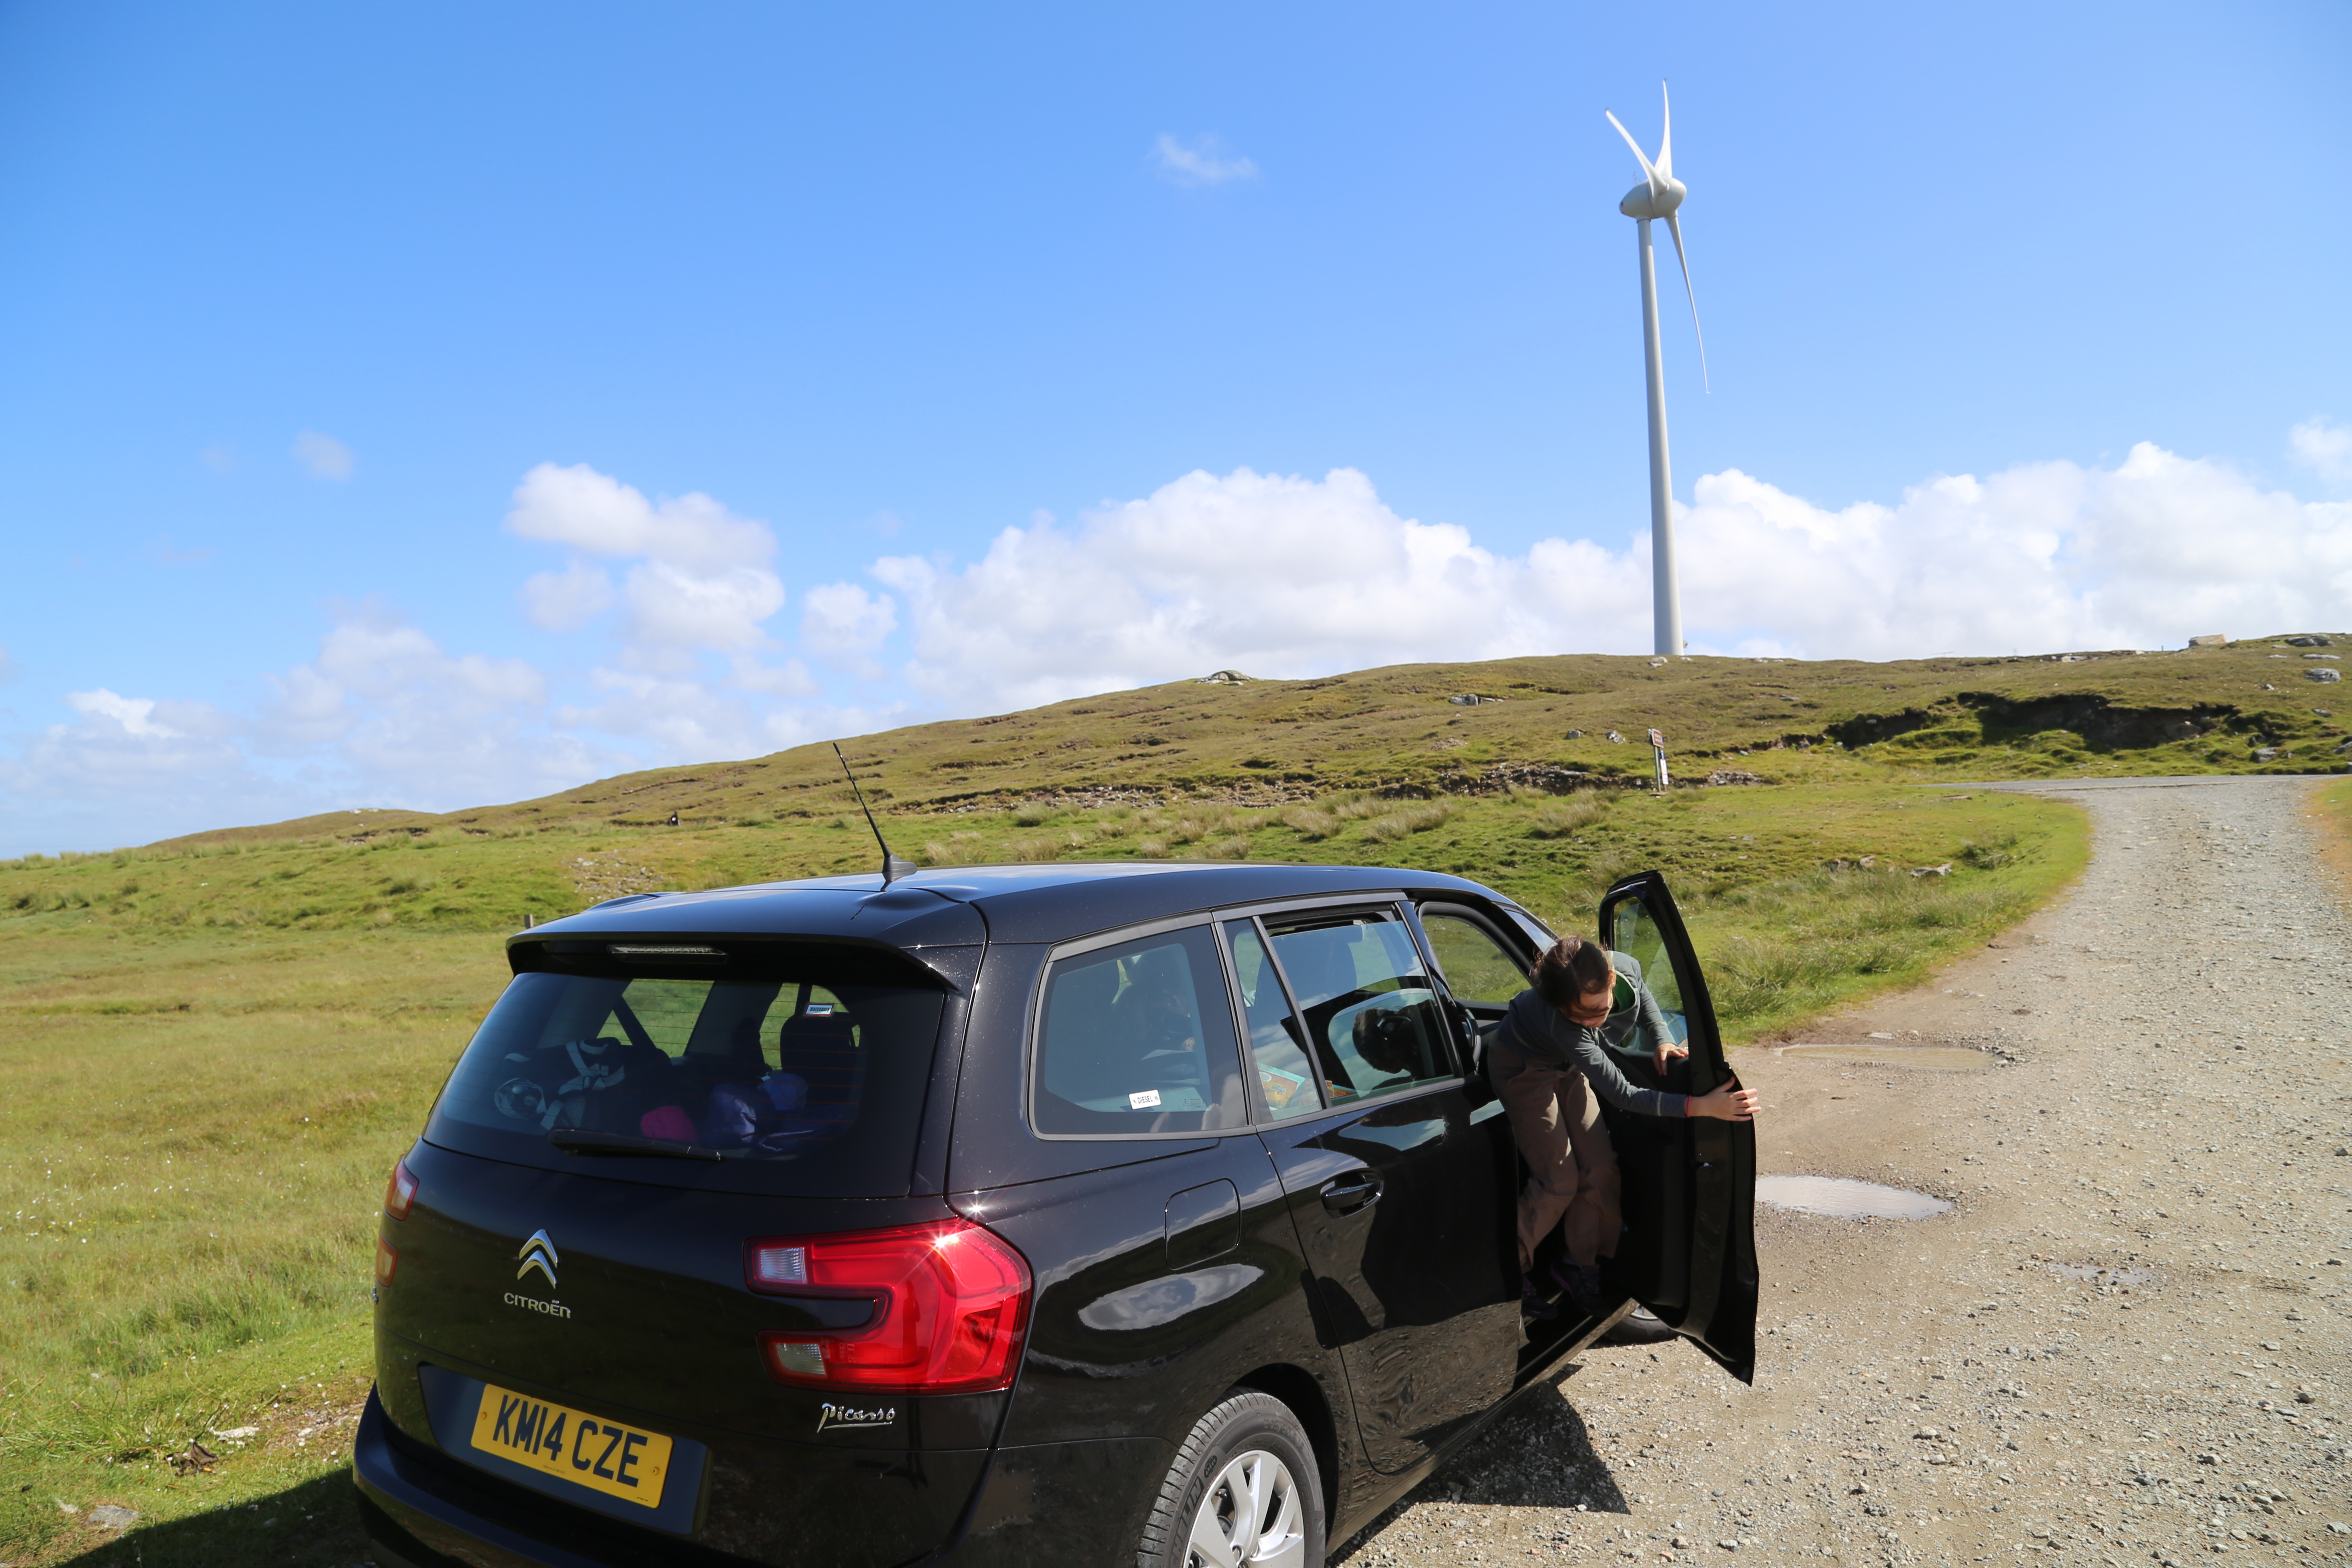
{"left": 426, "top": 973, "right": 943, "bottom": 1197}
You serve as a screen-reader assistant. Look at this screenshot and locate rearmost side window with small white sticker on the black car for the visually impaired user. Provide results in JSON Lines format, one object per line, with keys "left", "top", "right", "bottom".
{"left": 1030, "top": 926, "right": 1249, "bottom": 1138}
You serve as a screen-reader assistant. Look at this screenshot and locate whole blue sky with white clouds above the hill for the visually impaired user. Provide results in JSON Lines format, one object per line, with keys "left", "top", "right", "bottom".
{"left": 0, "top": 2, "right": 2352, "bottom": 853}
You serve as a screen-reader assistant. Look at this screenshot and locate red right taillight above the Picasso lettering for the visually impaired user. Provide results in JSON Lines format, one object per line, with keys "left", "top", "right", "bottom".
{"left": 743, "top": 1220, "right": 1030, "bottom": 1394}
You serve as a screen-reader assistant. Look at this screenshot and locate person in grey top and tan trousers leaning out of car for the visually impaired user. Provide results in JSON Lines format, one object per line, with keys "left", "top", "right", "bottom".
{"left": 1486, "top": 936, "right": 1757, "bottom": 1317}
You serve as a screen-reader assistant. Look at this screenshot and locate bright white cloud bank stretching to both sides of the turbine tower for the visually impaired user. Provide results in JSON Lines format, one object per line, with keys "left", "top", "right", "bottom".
{"left": 873, "top": 444, "right": 2352, "bottom": 710}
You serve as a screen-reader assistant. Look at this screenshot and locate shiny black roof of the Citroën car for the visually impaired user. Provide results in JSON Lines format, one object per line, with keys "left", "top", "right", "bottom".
{"left": 513, "top": 861, "right": 1496, "bottom": 947}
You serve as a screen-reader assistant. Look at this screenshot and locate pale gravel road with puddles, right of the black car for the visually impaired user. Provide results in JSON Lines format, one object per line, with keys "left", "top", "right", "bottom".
{"left": 1336, "top": 778, "right": 2352, "bottom": 1568}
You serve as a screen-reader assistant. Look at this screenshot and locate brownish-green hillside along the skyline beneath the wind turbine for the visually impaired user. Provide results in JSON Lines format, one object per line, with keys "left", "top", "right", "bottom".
{"left": 138, "top": 635, "right": 2352, "bottom": 844}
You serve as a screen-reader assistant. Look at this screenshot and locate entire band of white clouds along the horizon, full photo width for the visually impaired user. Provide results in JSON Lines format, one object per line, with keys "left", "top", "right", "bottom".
{"left": 0, "top": 435, "right": 2352, "bottom": 853}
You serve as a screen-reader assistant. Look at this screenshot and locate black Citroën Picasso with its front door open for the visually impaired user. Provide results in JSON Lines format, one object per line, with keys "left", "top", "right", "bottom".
{"left": 355, "top": 863, "right": 1757, "bottom": 1568}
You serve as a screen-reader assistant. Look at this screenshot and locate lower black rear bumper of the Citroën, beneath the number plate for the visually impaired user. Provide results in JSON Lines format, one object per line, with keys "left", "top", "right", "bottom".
{"left": 350, "top": 1392, "right": 1176, "bottom": 1568}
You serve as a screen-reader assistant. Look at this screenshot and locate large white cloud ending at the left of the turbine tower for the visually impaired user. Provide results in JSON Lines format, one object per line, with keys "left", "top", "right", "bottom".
{"left": 873, "top": 468, "right": 1649, "bottom": 707}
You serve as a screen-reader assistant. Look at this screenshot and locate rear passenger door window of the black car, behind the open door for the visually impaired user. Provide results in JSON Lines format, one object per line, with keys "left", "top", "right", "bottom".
{"left": 1263, "top": 910, "right": 1461, "bottom": 1105}
